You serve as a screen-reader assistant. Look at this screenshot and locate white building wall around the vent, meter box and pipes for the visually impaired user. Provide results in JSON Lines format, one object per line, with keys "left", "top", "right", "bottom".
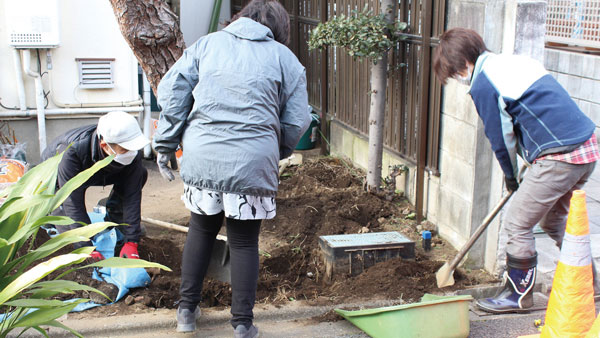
{"left": 0, "top": 0, "right": 139, "bottom": 108}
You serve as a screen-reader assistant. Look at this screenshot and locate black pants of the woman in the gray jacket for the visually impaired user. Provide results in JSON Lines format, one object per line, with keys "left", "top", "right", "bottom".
{"left": 180, "top": 212, "right": 261, "bottom": 328}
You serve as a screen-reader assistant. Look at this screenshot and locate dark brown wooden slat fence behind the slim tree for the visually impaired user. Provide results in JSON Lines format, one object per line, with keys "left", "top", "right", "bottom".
{"left": 232, "top": 0, "right": 445, "bottom": 173}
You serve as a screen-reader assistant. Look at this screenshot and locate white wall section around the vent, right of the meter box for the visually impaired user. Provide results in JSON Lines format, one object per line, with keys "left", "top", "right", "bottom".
{"left": 47, "top": 0, "right": 139, "bottom": 103}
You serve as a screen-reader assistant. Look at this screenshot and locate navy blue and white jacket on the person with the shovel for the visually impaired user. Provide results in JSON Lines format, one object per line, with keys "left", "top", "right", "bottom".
{"left": 469, "top": 52, "right": 595, "bottom": 178}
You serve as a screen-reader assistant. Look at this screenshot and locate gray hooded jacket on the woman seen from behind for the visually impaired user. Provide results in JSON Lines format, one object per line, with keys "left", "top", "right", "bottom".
{"left": 153, "top": 18, "right": 310, "bottom": 197}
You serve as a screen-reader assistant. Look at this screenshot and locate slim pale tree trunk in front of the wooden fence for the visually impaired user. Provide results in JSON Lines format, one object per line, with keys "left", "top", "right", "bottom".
{"left": 367, "top": 0, "right": 398, "bottom": 192}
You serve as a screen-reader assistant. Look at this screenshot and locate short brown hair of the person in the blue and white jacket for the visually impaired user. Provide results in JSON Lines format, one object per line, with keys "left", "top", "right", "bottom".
{"left": 433, "top": 28, "right": 488, "bottom": 84}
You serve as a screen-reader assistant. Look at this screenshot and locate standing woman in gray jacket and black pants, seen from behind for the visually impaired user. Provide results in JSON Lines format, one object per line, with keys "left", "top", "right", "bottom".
{"left": 153, "top": 0, "right": 310, "bottom": 337}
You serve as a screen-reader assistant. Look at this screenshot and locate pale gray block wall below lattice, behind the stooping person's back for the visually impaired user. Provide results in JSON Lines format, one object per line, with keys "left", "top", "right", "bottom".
{"left": 544, "top": 48, "right": 600, "bottom": 138}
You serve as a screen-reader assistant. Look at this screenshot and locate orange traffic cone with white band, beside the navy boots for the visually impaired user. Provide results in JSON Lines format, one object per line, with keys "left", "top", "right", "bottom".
{"left": 541, "top": 190, "right": 596, "bottom": 338}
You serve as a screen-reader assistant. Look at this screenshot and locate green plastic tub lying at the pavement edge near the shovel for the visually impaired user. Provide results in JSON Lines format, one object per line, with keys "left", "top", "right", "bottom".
{"left": 335, "top": 294, "right": 473, "bottom": 338}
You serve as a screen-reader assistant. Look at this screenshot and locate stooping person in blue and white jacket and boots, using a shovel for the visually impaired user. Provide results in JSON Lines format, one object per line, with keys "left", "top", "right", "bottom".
{"left": 433, "top": 28, "right": 600, "bottom": 313}
